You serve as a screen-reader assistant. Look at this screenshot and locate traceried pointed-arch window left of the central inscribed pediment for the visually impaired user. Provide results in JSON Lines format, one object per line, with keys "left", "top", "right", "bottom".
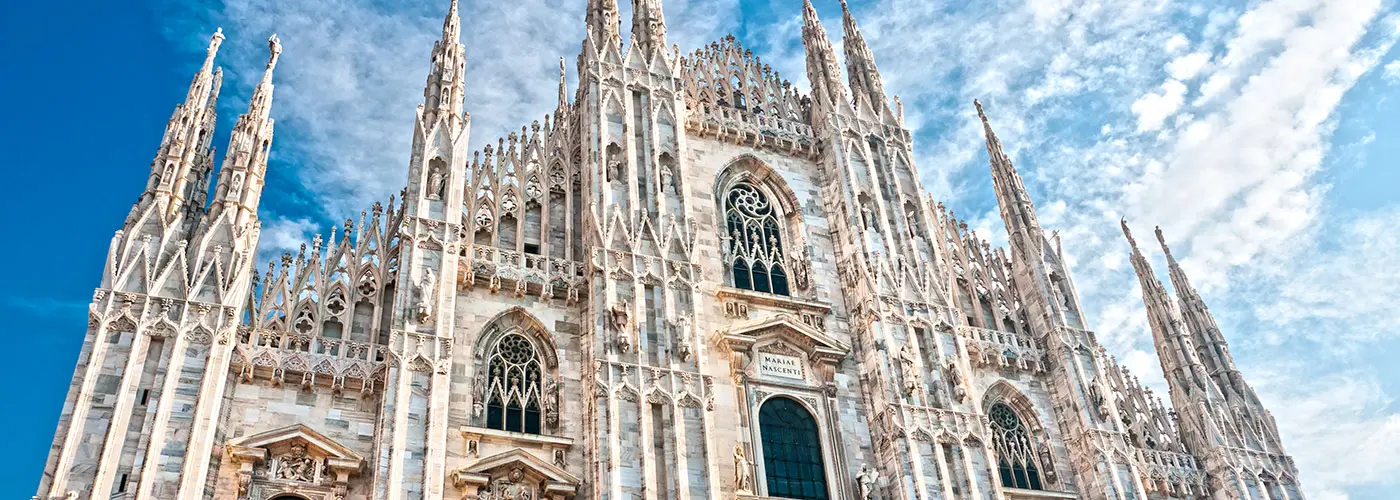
{"left": 486, "top": 333, "right": 543, "bottom": 434}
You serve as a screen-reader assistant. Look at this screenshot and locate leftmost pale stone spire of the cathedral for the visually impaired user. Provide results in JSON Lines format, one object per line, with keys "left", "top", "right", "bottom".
{"left": 145, "top": 28, "right": 224, "bottom": 217}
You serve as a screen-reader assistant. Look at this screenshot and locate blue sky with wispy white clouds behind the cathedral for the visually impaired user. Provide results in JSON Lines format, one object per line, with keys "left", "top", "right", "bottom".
{"left": 0, "top": 0, "right": 1400, "bottom": 500}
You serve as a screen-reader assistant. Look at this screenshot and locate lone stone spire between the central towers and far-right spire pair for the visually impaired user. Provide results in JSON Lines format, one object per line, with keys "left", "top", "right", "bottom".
{"left": 972, "top": 101, "right": 1044, "bottom": 258}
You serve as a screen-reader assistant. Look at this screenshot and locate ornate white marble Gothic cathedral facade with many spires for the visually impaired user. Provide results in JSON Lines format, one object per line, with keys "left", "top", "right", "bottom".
{"left": 35, "top": 0, "right": 1302, "bottom": 500}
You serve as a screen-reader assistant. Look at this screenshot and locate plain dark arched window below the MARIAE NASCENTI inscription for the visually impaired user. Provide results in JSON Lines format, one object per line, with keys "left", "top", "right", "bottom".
{"left": 759, "top": 398, "right": 826, "bottom": 500}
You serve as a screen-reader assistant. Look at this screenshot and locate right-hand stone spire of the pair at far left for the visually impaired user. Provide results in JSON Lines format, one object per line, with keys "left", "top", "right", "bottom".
{"left": 210, "top": 35, "right": 281, "bottom": 225}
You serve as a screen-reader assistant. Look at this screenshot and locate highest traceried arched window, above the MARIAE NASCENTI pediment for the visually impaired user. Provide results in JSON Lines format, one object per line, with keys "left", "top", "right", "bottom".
{"left": 724, "top": 182, "right": 788, "bottom": 296}
